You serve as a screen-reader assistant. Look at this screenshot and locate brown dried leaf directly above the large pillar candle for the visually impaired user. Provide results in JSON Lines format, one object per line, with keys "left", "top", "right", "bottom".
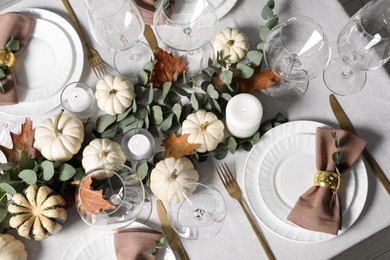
{"left": 238, "top": 68, "right": 280, "bottom": 94}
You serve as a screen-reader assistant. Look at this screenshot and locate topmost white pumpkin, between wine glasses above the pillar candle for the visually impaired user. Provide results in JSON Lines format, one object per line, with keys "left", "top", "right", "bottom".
{"left": 213, "top": 27, "right": 249, "bottom": 63}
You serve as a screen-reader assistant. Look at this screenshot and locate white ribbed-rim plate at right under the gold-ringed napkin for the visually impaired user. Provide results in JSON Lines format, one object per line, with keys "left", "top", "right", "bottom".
{"left": 244, "top": 121, "right": 368, "bottom": 242}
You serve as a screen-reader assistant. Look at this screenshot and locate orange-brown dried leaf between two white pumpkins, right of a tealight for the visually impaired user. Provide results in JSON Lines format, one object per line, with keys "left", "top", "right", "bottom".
{"left": 161, "top": 133, "right": 197, "bottom": 159}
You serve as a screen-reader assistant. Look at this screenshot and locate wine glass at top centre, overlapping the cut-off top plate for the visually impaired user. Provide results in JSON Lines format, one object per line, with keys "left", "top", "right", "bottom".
{"left": 153, "top": 0, "right": 218, "bottom": 71}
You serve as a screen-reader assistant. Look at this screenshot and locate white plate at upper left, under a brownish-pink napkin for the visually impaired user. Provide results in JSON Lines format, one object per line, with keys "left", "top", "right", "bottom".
{"left": 0, "top": 8, "right": 84, "bottom": 116}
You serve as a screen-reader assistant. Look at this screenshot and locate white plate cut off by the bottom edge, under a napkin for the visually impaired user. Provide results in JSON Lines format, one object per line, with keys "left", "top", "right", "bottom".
{"left": 61, "top": 222, "right": 176, "bottom": 260}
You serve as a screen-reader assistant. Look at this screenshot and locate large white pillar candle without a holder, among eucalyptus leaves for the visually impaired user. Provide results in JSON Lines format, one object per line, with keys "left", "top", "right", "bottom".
{"left": 226, "top": 94, "right": 263, "bottom": 138}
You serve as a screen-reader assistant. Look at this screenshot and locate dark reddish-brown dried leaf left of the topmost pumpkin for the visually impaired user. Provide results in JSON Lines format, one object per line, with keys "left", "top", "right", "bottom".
{"left": 150, "top": 47, "right": 186, "bottom": 88}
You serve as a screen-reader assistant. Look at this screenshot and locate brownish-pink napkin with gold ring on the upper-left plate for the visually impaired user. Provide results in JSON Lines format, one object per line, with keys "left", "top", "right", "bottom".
{"left": 0, "top": 13, "right": 34, "bottom": 105}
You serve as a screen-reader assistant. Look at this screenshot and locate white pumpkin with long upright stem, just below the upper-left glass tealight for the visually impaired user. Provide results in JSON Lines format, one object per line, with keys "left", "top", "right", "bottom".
{"left": 34, "top": 111, "right": 84, "bottom": 162}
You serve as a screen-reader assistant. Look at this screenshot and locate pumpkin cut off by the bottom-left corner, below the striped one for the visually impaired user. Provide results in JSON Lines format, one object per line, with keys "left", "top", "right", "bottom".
{"left": 0, "top": 234, "right": 27, "bottom": 260}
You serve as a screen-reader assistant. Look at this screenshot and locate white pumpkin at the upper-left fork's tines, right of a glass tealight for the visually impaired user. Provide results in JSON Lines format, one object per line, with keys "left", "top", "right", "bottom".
{"left": 95, "top": 75, "right": 134, "bottom": 115}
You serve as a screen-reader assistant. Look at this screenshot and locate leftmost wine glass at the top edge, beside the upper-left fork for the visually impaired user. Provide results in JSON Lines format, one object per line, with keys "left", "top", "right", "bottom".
{"left": 85, "top": 0, "right": 153, "bottom": 79}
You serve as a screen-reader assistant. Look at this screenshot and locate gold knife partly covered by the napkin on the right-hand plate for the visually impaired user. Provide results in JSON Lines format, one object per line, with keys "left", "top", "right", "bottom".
{"left": 329, "top": 94, "right": 390, "bottom": 195}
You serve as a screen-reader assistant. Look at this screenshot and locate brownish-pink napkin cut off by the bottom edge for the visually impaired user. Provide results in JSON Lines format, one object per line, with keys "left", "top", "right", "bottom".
{"left": 114, "top": 228, "right": 163, "bottom": 260}
